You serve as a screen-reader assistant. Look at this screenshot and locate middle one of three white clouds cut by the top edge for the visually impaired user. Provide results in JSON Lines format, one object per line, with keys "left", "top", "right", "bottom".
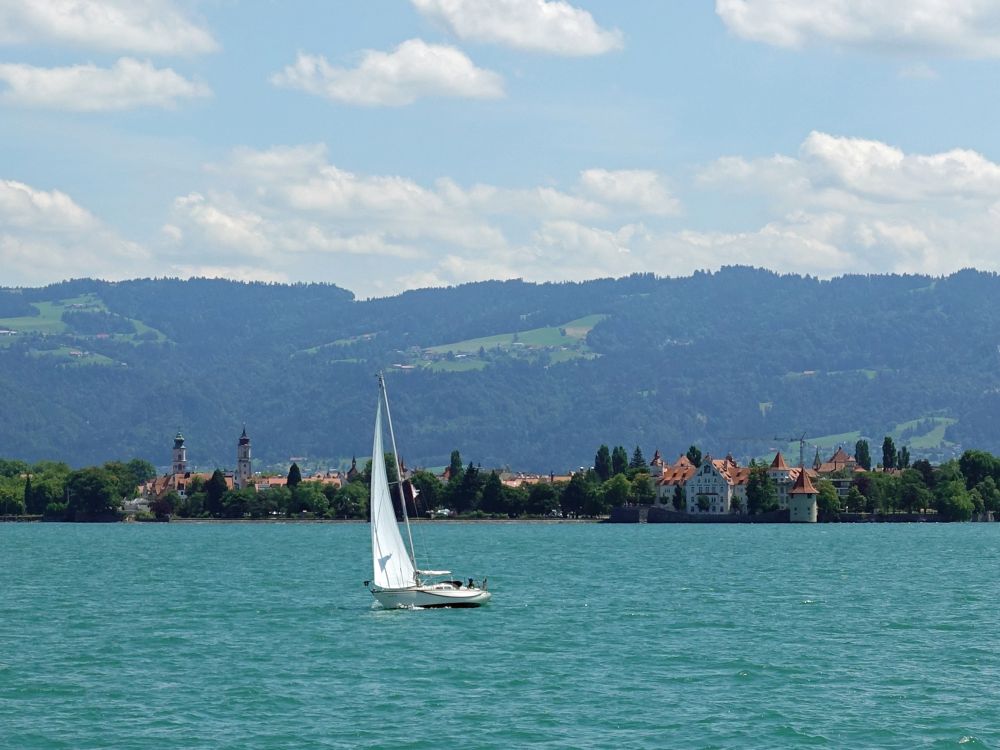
{"left": 411, "top": 0, "right": 623, "bottom": 56}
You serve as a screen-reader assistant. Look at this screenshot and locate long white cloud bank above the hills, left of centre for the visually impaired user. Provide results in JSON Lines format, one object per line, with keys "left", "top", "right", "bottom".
{"left": 162, "top": 145, "right": 696, "bottom": 295}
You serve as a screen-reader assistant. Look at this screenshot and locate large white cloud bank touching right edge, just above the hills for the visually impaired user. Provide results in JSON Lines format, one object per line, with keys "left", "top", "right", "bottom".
{"left": 692, "top": 132, "right": 1000, "bottom": 276}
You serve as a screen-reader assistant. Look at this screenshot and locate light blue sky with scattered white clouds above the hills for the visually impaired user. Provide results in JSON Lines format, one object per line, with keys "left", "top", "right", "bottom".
{"left": 0, "top": 0, "right": 1000, "bottom": 298}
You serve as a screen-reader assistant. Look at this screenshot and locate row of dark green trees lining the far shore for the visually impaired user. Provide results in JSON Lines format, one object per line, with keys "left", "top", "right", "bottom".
{"left": 0, "top": 439, "right": 1000, "bottom": 521}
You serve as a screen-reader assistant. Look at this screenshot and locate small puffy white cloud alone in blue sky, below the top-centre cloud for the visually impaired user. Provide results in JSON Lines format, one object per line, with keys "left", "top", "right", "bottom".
{"left": 271, "top": 39, "right": 504, "bottom": 106}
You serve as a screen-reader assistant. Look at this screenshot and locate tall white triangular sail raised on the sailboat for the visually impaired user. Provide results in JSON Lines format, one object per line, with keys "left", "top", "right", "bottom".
{"left": 371, "top": 398, "right": 417, "bottom": 589}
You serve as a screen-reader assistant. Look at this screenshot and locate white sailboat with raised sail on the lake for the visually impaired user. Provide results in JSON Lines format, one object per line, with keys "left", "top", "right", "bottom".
{"left": 365, "top": 373, "right": 491, "bottom": 609}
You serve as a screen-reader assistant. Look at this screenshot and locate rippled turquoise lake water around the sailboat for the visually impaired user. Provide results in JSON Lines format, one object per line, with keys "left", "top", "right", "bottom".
{"left": 0, "top": 523, "right": 1000, "bottom": 750}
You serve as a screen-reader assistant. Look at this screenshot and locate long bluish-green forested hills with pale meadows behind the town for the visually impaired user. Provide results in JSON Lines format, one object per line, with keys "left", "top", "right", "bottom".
{"left": 0, "top": 268, "right": 1000, "bottom": 471}
